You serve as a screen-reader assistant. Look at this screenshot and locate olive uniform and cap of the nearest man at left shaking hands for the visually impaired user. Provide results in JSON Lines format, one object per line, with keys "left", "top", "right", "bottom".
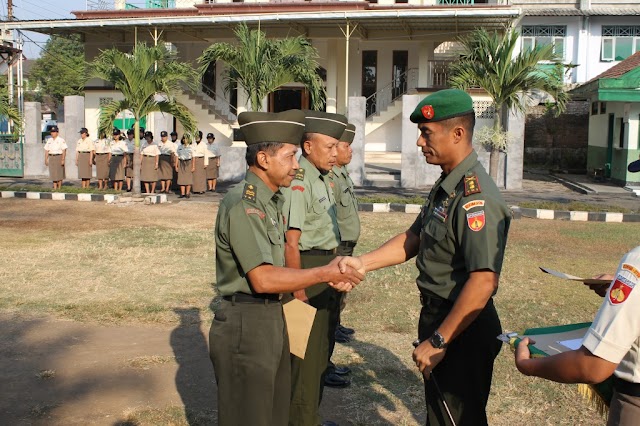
{"left": 209, "top": 111, "right": 304, "bottom": 426}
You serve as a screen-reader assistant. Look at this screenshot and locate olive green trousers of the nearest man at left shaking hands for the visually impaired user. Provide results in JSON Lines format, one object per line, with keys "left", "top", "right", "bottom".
{"left": 209, "top": 301, "right": 291, "bottom": 426}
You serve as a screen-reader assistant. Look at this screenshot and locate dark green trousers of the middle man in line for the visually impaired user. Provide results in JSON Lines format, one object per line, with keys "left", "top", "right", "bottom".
{"left": 289, "top": 254, "right": 335, "bottom": 426}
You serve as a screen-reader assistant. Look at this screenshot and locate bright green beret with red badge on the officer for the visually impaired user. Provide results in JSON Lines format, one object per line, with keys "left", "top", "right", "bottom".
{"left": 410, "top": 89, "right": 473, "bottom": 123}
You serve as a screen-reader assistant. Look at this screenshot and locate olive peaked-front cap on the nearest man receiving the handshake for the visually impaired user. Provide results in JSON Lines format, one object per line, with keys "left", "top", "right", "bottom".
{"left": 238, "top": 109, "right": 305, "bottom": 145}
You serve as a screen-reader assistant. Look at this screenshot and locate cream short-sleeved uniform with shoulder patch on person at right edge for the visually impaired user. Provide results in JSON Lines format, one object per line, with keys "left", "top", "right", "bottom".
{"left": 582, "top": 247, "right": 640, "bottom": 426}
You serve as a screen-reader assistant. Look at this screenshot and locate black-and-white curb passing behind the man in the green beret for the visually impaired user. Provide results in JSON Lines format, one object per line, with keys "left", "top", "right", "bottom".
{"left": 358, "top": 203, "right": 640, "bottom": 223}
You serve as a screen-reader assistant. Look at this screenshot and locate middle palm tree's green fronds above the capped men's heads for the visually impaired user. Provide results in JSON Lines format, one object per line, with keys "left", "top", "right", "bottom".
{"left": 198, "top": 23, "right": 325, "bottom": 111}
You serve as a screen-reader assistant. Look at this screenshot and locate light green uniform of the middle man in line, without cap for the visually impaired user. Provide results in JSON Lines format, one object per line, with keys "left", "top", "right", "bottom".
{"left": 283, "top": 157, "right": 340, "bottom": 426}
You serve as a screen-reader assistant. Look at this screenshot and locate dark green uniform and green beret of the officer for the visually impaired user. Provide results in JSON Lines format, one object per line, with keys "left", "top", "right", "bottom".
{"left": 410, "top": 90, "right": 511, "bottom": 425}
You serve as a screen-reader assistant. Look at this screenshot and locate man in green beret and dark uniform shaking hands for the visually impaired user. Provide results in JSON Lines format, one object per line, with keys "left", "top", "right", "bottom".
{"left": 342, "top": 89, "right": 511, "bottom": 425}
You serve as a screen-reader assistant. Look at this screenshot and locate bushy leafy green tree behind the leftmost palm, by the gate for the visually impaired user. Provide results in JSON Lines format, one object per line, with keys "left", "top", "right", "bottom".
{"left": 30, "top": 35, "right": 87, "bottom": 105}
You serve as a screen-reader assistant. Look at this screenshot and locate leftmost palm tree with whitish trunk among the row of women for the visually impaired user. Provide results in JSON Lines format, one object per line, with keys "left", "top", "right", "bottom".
{"left": 91, "top": 43, "right": 198, "bottom": 195}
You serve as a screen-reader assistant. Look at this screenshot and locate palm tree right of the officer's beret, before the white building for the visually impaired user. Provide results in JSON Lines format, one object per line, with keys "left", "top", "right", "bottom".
{"left": 449, "top": 29, "right": 570, "bottom": 181}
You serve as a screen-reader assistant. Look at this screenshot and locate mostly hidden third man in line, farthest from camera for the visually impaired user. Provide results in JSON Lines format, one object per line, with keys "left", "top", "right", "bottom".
{"left": 324, "top": 123, "right": 360, "bottom": 388}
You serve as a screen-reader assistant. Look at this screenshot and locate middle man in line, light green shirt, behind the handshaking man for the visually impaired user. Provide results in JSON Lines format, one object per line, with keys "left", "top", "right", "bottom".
{"left": 283, "top": 111, "right": 347, "bottom": 426}
